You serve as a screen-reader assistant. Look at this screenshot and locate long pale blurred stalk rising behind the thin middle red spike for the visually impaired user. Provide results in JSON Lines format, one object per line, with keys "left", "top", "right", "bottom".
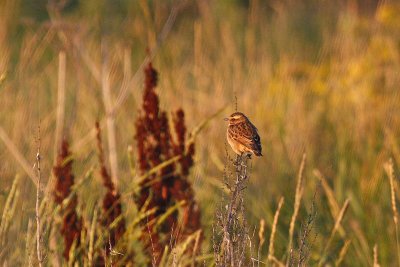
{"left": 101, "top": 43, "right": 118, "bottom": 186}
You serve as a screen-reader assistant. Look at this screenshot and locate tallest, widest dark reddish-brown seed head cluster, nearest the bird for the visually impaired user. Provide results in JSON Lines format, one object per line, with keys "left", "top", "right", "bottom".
{"left": 135, "top": 61, "right": 200, "bottom": 260}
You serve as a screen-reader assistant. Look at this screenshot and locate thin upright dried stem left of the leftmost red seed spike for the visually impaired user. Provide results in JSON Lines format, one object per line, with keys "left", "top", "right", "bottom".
{"left": 35, "top": 127, "right": 43, "bottom": 267}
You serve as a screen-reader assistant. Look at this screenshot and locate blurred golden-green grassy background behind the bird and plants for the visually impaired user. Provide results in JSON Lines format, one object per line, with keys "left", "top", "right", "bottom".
{"left": 0, "top": 0, "right": 400, "bottom": 266}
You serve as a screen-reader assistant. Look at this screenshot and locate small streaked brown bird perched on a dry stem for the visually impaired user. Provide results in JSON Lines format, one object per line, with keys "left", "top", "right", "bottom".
{"left": 225, "top": 112, "right": 262, "bottom": 158}
